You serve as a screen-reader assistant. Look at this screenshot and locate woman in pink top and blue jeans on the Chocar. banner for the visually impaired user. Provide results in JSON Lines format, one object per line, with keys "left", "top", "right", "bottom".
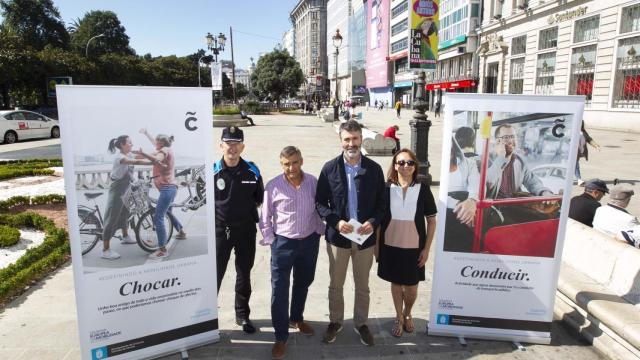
{"left": 139, "top": 129, "right": 187, "bottom": 259}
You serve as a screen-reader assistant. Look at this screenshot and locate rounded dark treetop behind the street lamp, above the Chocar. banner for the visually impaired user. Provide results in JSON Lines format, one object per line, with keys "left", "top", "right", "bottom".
{"left": 69, "top": 10, "right": 135, "bottom": 58}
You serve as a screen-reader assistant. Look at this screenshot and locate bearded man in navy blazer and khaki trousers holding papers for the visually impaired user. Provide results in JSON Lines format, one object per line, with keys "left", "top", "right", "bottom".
{"left": 316, "top": 120, "right": 385, "bottom": 346}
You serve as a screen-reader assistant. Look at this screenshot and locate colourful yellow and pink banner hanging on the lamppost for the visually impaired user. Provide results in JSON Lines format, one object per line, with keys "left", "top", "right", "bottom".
{"left": 409, "top": 0, "right": 440, "bottom": 71}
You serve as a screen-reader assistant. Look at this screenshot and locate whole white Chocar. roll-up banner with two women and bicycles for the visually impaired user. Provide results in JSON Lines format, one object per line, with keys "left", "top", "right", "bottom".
{"left": 57, "top": 86, "right": 219, "bottom": 359}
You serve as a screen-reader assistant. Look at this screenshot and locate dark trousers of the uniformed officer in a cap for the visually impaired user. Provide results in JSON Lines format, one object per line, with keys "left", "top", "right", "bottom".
{"left": 216, "top": 222, "right": 257, "bottom": 319}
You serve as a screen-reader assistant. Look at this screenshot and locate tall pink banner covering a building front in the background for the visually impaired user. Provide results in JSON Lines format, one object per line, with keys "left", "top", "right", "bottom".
{"left": 366, "top": 0, "right": 390, "bottom": 88}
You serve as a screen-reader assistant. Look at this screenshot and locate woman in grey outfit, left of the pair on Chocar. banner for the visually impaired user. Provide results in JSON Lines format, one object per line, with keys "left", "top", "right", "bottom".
{"left": 101, "top": 135, "right": 151, "bottom": 260}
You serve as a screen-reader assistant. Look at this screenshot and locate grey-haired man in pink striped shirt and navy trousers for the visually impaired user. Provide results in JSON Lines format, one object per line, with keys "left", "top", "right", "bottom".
{"left": 259, "top": 146, "right": 324, "bottom": 359}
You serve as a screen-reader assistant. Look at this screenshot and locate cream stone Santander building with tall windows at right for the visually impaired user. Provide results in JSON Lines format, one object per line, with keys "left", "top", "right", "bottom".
{"left": 477, "top": 0, "right": 640, "bottom": 132}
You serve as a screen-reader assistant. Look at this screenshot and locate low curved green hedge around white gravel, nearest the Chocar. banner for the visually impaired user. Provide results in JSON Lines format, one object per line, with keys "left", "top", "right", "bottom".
{"left": 0, "top": 212, "right": 70, "bottom": 303}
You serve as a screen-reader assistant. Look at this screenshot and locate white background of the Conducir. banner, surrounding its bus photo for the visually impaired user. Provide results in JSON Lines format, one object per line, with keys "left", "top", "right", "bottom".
{"left": 428, "top": 93, "right": 584, "bottom": 344}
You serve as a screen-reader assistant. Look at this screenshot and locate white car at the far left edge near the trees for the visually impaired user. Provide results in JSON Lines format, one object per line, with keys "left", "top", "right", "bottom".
{"left": 0, "top": 110, "right": 60, "bottom": 144}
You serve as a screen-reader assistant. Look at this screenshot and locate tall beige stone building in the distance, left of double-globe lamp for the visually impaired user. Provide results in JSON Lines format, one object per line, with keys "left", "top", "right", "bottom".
{"left": 289, "top": 0, "right": 327, "bottom": 96}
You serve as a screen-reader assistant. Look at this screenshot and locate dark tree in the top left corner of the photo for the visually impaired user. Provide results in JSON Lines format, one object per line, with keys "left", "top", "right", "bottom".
{"left": 0, "top": 0, "right": 69, "bottom": 50}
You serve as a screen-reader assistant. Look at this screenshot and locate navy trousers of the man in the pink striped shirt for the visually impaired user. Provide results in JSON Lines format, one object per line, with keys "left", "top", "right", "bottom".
{"left": 271, "top": 233, "right": 320, "bottom": 341}
